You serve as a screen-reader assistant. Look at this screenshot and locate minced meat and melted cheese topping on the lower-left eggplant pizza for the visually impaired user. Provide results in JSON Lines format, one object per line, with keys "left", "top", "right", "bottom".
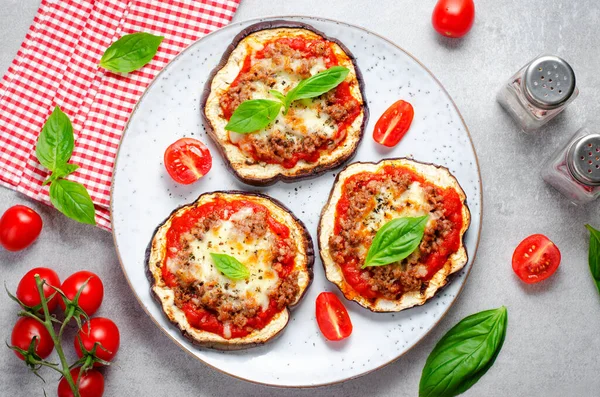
{"left": 167, "top": 209, "right": 299, "bottom": 331}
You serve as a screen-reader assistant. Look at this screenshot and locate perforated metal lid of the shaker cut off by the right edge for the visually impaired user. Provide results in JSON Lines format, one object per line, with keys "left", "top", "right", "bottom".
{"left": 567, "top": 134, "right": 600, "bottom": 186}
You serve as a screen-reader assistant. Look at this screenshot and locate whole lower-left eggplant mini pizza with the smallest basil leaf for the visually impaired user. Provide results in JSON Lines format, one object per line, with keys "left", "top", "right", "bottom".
{"left": 146, "top": 191, "right": 314, "bottom": 350}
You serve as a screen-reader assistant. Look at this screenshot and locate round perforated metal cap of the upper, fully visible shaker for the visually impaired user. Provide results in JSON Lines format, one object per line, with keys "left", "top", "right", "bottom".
{"left": 523, "top": 55, "right": 575, "bottom": 110}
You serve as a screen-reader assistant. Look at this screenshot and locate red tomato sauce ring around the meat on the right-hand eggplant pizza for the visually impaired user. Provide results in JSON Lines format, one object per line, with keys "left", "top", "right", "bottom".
{"left": 334, "top": 166, "right": 463, "bottom": 299}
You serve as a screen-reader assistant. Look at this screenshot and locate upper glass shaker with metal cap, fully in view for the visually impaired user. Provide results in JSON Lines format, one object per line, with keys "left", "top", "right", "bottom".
{"left": 497, "top": 55, "right": 579, "bottom": 133}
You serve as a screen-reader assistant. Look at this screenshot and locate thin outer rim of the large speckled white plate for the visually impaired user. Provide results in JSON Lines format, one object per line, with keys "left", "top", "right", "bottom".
{"left": 109, "top": 14, "right": 483, "bottom": 389}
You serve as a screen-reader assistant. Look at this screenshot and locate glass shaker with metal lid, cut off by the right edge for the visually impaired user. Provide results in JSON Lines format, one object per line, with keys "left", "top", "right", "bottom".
{"left": 542, "top": 127, "right": 600, "bottom": 205}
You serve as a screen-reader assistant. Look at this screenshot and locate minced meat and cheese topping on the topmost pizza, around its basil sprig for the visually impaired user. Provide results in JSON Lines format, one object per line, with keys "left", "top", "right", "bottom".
{"left": 220, "top": 36, "right": 361, "bottom": 168}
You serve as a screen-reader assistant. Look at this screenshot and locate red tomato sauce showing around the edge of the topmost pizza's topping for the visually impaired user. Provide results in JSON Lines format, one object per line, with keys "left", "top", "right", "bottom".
{"left": 221, "top": 37, "right": 362, "bottom": 169}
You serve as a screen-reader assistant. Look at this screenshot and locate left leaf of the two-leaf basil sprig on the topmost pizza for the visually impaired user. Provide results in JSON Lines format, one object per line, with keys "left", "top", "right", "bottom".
{"left": 225, "top": 99, "right": 283, "bottom": 134}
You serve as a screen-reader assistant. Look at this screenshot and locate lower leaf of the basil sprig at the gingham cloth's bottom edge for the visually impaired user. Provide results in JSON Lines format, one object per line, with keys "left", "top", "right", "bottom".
{"left": 50, "top": 179, "right": 96, "bottom": 225}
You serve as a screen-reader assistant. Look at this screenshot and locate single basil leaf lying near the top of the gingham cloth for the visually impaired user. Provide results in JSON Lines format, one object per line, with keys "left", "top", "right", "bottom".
{"left": 100, "top": 32, "right": 165, "bottom": 73}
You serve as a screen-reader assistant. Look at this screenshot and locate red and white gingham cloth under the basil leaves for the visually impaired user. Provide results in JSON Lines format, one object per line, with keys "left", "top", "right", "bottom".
{"left": 0, "top": 0, "right": 240, "bottom": 230}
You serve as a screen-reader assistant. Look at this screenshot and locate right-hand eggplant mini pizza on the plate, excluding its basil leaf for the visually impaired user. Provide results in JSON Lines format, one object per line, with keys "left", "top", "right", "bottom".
{"left": 318, "top": 159, "right": 470, "bottom": 312}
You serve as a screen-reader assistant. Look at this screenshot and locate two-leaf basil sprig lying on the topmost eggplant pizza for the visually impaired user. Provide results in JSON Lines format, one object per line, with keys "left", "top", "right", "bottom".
{"left": 225, "top": 66, "right": 350, "bottom": 134}
